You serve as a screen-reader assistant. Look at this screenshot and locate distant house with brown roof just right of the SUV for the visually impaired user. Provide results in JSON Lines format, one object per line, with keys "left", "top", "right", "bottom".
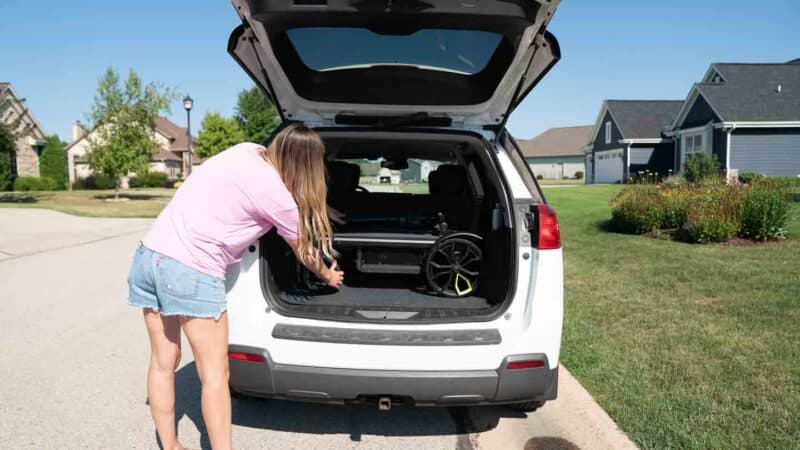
{"left": 517, "top": 125, "right": 592, "bottom": 180}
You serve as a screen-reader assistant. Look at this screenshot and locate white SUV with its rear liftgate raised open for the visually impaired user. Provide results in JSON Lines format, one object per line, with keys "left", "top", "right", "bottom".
{"left": 226, "top": 0, "right": 563, "bottom": 411}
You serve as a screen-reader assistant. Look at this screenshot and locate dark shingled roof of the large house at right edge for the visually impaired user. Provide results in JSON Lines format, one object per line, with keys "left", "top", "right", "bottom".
{"left": 673, "top": 60, "right": 800, "bottom": 128}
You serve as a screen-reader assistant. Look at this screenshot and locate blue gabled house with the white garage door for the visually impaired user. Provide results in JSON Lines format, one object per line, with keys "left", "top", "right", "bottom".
{"left": 586, "top": 100, "right": 683, "bottom": 183}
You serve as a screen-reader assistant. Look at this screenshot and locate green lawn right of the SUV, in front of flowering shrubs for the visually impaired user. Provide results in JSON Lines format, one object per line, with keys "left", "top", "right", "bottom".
{"left": 545, "top": 186, "right": 800, "bottom": 449}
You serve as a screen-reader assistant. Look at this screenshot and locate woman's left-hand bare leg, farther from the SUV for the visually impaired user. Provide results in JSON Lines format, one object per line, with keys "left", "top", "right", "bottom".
{"left": 144, "top": 308, "right": 183, "bottom": 450}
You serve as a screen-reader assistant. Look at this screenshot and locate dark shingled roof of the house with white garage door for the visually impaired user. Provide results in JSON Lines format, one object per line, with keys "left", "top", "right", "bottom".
{"left": 601, "top": 100, "right": 683, "bottom": 139}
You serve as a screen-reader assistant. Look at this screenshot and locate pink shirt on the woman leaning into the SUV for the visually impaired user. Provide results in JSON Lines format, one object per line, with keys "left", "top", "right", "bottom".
{"left": 142, "top": 143, "right": 298, "bottom": 278}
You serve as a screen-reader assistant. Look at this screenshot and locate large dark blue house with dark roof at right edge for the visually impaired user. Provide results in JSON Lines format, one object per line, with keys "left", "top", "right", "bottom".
{"left": 666, "top": 60, "right": 800, "bottom": 177}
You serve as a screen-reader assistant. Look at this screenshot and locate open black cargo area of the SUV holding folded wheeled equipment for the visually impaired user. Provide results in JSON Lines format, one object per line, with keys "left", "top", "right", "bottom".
{"left": 260, "top": 131, "right": 515, "bottom": 321}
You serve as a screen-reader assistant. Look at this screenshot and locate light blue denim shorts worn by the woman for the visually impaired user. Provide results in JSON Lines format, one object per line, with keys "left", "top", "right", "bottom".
{"left": 128, "top": 245, "right": 226, "bottom": 319}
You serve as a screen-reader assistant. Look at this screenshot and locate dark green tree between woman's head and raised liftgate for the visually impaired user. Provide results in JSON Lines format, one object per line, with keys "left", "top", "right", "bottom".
{"left": 235, "top": 86, "right": 280, "bottom": 145}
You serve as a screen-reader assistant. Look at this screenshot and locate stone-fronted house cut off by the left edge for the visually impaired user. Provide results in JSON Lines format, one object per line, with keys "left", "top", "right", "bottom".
{"left": 0, "top": 82, "right": 47, "bottom": 178}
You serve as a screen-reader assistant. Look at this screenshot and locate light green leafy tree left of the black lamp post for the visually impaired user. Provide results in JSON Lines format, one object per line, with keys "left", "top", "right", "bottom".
{"left": 87, "top": 67, "right": 177, "bottom": 198}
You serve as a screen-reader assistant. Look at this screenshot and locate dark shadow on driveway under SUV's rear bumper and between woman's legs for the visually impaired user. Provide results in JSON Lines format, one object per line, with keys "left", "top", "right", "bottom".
{"left": 175, "top": 362, "right": 538, "bottom": 449}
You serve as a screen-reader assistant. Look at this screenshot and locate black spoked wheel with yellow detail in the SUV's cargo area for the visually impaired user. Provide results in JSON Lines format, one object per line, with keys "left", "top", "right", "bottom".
{"left": 425, "top": 236, "right": 483, "bottom": 297}
